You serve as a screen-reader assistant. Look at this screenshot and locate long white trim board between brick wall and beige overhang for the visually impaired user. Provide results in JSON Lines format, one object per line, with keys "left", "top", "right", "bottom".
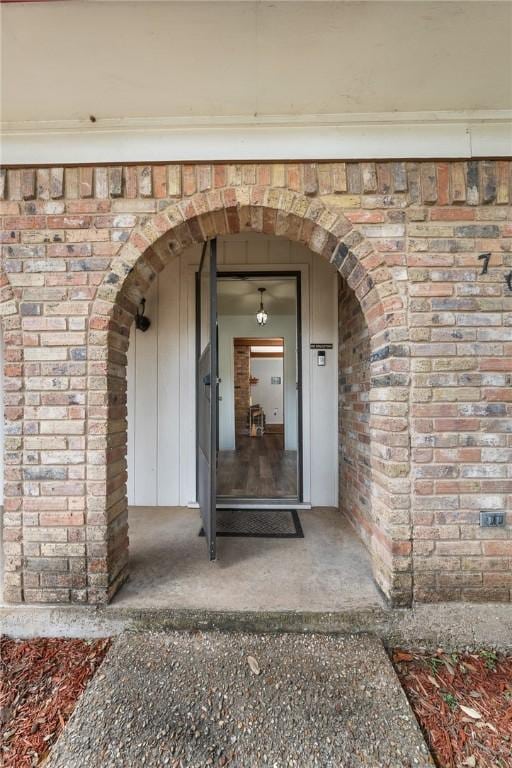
{"left": 1, "top": 110, "right": 512, "bottom": 166}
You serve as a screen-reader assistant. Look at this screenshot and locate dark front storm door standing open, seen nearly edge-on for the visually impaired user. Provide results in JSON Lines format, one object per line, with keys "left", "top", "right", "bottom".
{"left": 196, "top": 239, "right": 218, "bottom": 560}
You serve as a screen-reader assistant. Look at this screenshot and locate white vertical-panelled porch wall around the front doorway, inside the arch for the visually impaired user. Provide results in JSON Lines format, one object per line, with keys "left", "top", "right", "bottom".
{"left": 128, "top": 233, "right": 338, "bottom": 506}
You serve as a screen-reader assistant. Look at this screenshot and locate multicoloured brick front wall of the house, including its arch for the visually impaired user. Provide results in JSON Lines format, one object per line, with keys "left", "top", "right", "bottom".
{"left": 0, "top": 161, "right": 512, "bottom": 604}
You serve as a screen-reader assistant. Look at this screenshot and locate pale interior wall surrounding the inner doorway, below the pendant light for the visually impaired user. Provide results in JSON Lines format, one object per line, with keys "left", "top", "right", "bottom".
{"left": 218, "top": 315, "right": 297, "bottom": 451}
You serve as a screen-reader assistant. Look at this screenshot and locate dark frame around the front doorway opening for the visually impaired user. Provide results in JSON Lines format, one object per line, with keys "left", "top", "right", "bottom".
{"left": 210, "top": 265, "right": 304, "bottom": 506}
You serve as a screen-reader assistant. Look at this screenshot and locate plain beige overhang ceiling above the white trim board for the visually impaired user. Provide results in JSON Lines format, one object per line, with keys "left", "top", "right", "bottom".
{"left": 1, "top": 0, "right": 512, "bottom": 123}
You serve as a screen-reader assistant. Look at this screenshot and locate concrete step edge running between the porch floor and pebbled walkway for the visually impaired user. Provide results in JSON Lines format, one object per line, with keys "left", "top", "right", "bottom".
{"left": 0, "top": 603, "right": 512, "bottom": 652}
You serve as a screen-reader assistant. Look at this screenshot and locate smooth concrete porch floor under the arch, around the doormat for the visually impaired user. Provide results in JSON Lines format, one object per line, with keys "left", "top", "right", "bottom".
{"left": 113, "top": 507, "right": 384, "bottom": 611}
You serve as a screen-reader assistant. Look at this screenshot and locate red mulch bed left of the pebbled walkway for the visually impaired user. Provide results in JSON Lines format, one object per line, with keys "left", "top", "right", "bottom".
{"left": 0, "top": 637, "right": 110, "bottom": 768}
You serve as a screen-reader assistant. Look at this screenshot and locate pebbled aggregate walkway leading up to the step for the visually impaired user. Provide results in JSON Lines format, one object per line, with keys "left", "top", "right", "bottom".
{"left": 47, "top": 632, "right": 433, "bottom": 768}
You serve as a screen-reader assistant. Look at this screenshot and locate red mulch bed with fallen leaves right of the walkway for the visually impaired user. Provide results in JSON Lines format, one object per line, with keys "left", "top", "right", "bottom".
{"left": 392, "top": 649, "right": 512, "bottom": 768}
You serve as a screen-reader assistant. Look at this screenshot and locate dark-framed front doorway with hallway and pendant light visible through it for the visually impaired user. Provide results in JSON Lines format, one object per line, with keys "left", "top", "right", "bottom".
{"left": 217, "top": 271, "right": 302, "bottom": 506}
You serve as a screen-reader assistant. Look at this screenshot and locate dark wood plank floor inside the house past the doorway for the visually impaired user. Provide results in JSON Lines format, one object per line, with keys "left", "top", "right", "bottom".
{"left": 217, "top": 434, "right": 298, "bottom": 499}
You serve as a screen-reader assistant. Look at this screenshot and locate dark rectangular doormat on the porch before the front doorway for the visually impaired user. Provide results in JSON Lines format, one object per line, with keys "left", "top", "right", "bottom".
{"left": 199, "top": 509, "right": 304, "bottom": 539}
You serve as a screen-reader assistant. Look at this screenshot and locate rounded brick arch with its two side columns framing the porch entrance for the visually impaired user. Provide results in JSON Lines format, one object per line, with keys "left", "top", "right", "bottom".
{"left": 86, "top": 187, "right": 412, "bottom": 605}
